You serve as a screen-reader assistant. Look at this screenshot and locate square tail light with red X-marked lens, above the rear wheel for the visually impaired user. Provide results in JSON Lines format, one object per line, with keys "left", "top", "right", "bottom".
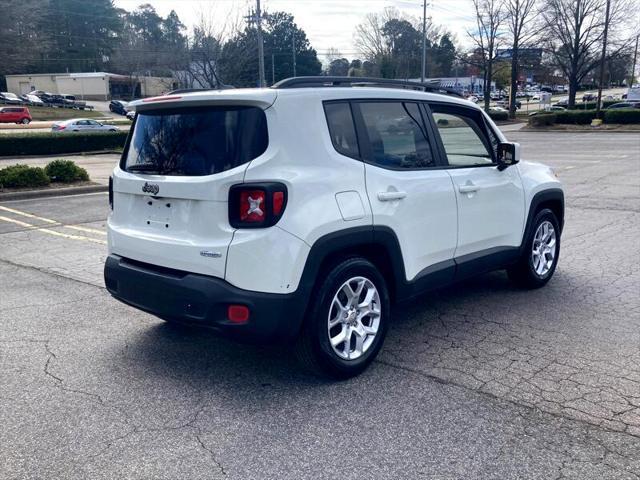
{"left": 229, "top": 182, "right": 287, "bottom": 228}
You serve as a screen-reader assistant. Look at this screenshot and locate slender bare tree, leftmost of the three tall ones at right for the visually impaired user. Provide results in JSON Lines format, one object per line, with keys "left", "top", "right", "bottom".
{"left": 467, "top": 0, "right": 505, "bottom": 111}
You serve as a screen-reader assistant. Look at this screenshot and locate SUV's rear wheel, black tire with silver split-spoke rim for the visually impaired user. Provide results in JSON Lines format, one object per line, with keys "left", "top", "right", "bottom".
{"left": 296, "top": 257, "right": 391, "bottom": 379}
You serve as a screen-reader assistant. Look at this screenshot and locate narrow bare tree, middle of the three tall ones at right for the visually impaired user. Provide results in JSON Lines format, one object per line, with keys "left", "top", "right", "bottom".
{"left": 505, "top": 0, "right": 539, "bottom": 118}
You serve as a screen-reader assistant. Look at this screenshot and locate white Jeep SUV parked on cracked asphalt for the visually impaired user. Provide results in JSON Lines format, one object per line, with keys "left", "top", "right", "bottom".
{"left": 105, "top": 77, "right": 564, "bottom": 377}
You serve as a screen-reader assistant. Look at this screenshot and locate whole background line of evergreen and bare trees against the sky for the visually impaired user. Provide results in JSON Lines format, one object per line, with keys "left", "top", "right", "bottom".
{"left": 0, "top": 0, "right": 640, "bottom": 113}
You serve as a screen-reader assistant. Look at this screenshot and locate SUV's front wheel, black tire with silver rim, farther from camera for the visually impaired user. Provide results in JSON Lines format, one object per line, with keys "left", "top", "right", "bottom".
{"left": 507, "top": 208, "right": 560, "bottom": 288}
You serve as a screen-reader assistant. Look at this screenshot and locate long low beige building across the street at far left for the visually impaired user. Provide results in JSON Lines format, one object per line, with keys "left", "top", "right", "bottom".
{"left": 6, "top": 72, "right": 177, "bottom": 100}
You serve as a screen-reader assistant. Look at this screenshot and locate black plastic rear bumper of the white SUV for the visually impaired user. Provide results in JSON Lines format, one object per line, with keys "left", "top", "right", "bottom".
{"left": 104, "top": 255, "right": 306, "bottom": 343}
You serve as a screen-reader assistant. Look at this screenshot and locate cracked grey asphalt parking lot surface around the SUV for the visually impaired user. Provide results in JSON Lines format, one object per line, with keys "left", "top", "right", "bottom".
{"left": 0, "top": 131, "right": 640, "bottom": 479}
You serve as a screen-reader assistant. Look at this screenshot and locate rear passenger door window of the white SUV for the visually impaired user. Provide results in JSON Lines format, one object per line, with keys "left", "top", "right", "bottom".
{"left": 359, "top": 102, "right": 436, "bottom": 169}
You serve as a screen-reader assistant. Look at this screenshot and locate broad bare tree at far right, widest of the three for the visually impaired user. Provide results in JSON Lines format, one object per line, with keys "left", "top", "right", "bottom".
{"left": 542, "top": 0, "right": 633, "bottom": 108}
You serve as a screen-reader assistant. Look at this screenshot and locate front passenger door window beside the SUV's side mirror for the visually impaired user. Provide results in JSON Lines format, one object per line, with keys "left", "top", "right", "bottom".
{"left": 433, "top": 111, "right": 493, "bottom": 167}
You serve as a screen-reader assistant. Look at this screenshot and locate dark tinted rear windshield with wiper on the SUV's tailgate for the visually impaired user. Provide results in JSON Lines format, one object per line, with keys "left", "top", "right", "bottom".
{"left": 122, "top": 107, "right": 269, "bottom": 176}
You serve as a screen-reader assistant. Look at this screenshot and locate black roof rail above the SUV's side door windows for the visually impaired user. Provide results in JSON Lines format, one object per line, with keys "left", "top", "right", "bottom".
{"left": 271, "top": 76, "right": 464, "bottom": 98}
